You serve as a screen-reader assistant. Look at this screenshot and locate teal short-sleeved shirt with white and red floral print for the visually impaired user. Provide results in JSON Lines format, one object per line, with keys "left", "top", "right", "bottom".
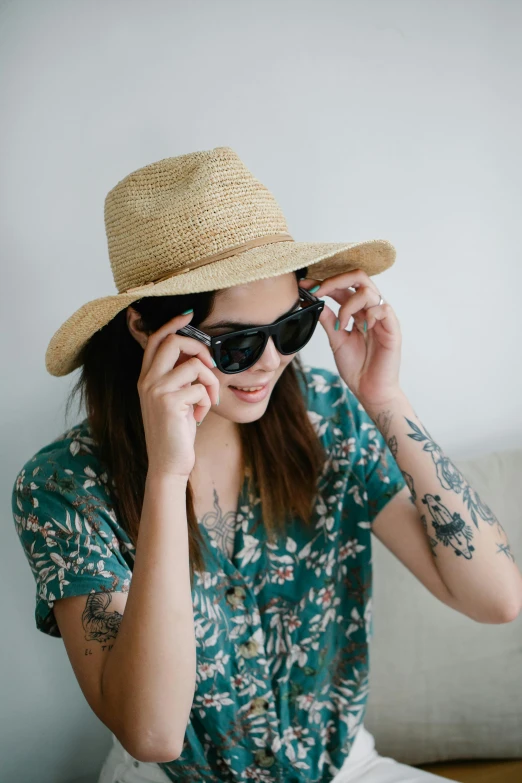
{"left": 12, "top": 365, "right": 406, "bottom": 783}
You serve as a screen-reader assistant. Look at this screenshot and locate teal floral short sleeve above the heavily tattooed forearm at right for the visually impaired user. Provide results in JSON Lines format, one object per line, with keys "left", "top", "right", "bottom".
{"left": 345, "top": 387, "right": 406, "bottom": 525}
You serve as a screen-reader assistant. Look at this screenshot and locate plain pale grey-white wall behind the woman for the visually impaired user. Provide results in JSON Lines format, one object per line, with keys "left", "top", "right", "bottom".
{"left": 0, "top": 0, "right": 522, "bottom": 783}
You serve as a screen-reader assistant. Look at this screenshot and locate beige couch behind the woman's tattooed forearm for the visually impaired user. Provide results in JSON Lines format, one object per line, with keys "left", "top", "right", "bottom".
{"left": 364, "top": 450, "right": 522, "bottom": 783}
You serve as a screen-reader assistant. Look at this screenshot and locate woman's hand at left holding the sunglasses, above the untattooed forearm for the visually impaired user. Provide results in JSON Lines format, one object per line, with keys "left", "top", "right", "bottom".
{"left": 138, "top": 313, "right": 219, "bottom": 480}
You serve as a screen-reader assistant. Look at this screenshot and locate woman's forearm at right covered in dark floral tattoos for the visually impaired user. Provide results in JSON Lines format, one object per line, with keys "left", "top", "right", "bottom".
{"left": 363, "top": 394, "right": 522, "bottom": 617}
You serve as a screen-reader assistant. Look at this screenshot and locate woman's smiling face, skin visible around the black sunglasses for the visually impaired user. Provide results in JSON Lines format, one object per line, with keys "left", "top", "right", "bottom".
{"left": 198, "top": 272, "right": 299, "bottom": 426}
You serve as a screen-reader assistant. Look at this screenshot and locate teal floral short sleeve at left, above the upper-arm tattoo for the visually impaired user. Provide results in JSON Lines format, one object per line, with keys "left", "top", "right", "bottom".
{"left": 12, "top": 460, "right": 132, "bottom": 637}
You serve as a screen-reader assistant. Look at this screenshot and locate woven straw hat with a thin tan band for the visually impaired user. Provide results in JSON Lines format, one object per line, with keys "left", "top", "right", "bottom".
{"left": 45, "top": 147, "right": 395, "bottom": 376}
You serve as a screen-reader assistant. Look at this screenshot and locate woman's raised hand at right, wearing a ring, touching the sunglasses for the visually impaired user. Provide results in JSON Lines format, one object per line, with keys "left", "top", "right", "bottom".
{"left": 300, "top": 269, "right": 402, "bottom": 406}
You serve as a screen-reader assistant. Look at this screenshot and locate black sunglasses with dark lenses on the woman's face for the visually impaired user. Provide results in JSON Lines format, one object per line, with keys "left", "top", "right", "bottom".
{"left": 177, "top": 286, "right": 324, "bottom": 374}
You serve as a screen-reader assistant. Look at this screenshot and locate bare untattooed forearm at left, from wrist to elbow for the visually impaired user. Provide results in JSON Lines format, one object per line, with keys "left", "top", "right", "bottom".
{"left": 103, "top": 474, "right": 196, "bottom": 761}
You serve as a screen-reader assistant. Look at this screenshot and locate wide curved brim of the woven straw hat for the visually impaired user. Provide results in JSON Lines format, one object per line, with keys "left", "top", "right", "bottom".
{"left": 45, "top": 239, "right": 395, "bottom": 377}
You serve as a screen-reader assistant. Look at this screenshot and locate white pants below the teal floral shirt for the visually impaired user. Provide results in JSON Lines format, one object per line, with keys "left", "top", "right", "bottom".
{"left": 98, "top": 724, "right": 456, "bottom": 783}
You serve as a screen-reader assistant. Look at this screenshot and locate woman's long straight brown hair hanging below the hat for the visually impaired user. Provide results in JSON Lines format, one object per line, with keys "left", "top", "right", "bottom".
{"left": 67, "top": 267, "right": 325, "bottom": 583}
